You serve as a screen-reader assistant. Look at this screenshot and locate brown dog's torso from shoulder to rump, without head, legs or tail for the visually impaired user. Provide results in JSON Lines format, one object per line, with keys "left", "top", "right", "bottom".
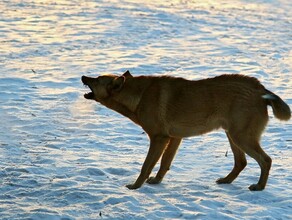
{"left": 138, "top": 75, "right": 268, "bottom": 137}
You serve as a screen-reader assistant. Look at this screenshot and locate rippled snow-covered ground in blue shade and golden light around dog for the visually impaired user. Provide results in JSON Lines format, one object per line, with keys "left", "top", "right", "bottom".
{"left": 0, "top": 0, "right": 292, "bottom": 220}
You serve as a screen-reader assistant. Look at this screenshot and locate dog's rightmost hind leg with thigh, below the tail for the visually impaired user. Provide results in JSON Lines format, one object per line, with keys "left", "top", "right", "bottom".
{"left": 230, "top": 133, "right": 272, "bottom": 191}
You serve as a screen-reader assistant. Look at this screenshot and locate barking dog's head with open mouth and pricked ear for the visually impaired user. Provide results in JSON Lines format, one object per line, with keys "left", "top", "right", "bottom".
{"left": 81, "top": 70, "right": 133, "bottom": 102}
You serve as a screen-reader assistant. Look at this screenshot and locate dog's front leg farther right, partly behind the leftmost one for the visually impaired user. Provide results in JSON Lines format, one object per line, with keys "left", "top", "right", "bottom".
{"left": 147, "top": 138, "right": 181, "bottom": 184}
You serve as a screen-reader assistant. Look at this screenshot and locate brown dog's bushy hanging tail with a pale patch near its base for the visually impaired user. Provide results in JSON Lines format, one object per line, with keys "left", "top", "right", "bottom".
{"left": 262, "top": 89, "right": 291, "bottom": 121}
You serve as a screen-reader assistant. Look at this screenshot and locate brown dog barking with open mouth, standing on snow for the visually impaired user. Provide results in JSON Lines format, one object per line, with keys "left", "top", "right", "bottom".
{"left": 81, "top": 71, "right": 291, "bottom": 191}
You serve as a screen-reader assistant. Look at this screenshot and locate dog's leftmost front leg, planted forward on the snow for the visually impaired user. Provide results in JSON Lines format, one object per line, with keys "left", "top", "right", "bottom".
{"left": 127, "top": 136, "right": 170, "bottom": 189}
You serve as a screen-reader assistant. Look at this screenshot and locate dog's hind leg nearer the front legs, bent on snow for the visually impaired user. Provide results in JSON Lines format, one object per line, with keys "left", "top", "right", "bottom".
{"left": 216, "top": 132, "right": 247, "bottom": 184}
